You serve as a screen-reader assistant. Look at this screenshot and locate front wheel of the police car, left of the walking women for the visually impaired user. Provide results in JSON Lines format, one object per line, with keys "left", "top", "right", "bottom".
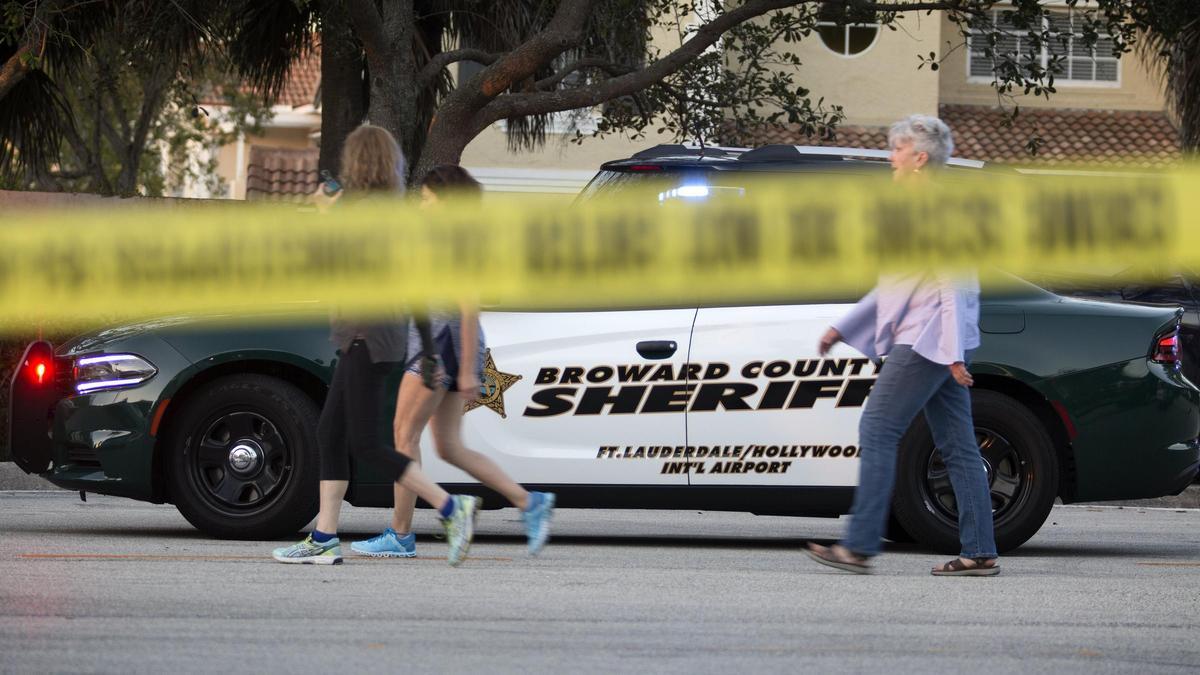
{"left": 166, "top": 375, "right": 320, "bottom": 539}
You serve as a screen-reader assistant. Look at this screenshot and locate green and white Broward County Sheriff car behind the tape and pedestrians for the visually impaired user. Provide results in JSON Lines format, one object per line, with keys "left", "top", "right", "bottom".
{"left": 12, "top": 145, "right": 1200, "bottom": 551}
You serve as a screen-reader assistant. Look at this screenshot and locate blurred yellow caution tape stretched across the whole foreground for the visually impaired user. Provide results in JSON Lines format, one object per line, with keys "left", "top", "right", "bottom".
{"left": 0, "top": 172, "right": 1200, "bottom": 323}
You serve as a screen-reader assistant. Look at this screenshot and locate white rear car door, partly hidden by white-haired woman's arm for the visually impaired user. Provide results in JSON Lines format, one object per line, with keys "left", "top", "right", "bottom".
{"left": 688, "top": 304, "right": 876, "bottom": 486}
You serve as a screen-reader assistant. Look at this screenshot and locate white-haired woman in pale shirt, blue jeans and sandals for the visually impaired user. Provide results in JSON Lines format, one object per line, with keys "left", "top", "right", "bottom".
{"left": 805, "top": 115, "right": 1000, "bottom": 577}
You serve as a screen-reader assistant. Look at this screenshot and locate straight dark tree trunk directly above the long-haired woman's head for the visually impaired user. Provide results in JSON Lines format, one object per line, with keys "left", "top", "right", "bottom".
{"left": 318, "top": 0, "right": 367, "bottom": 175}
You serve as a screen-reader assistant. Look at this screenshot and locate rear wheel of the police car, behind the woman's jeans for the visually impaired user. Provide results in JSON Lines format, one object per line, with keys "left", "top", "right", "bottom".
{"left": 892, "top": 390, "right": 1058, "bottom": 555}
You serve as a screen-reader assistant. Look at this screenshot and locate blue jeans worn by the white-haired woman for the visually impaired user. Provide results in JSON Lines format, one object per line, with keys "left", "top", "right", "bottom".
{"left": 841, "top": 345, "right": 996, "bottom": 557}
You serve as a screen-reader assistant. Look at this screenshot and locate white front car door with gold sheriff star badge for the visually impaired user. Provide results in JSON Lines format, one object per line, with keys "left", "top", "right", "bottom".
{"left": 422, "top": 307, "right": 696, "bottom": 485}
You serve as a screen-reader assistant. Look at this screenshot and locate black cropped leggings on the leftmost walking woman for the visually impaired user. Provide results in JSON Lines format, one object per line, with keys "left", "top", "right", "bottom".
{"left": 317, "top": 340, "right": 410, "bottom": 482}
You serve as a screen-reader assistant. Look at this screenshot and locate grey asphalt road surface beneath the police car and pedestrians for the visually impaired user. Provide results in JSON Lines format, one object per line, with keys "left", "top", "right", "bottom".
{"left": 0, "top": 491, "right": 1200, "bottom": 674}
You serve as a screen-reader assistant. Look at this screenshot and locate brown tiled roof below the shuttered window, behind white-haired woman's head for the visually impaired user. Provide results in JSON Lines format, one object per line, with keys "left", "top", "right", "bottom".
{"left": 755, "top": 104, "right": 1182, "bottom": 168}
